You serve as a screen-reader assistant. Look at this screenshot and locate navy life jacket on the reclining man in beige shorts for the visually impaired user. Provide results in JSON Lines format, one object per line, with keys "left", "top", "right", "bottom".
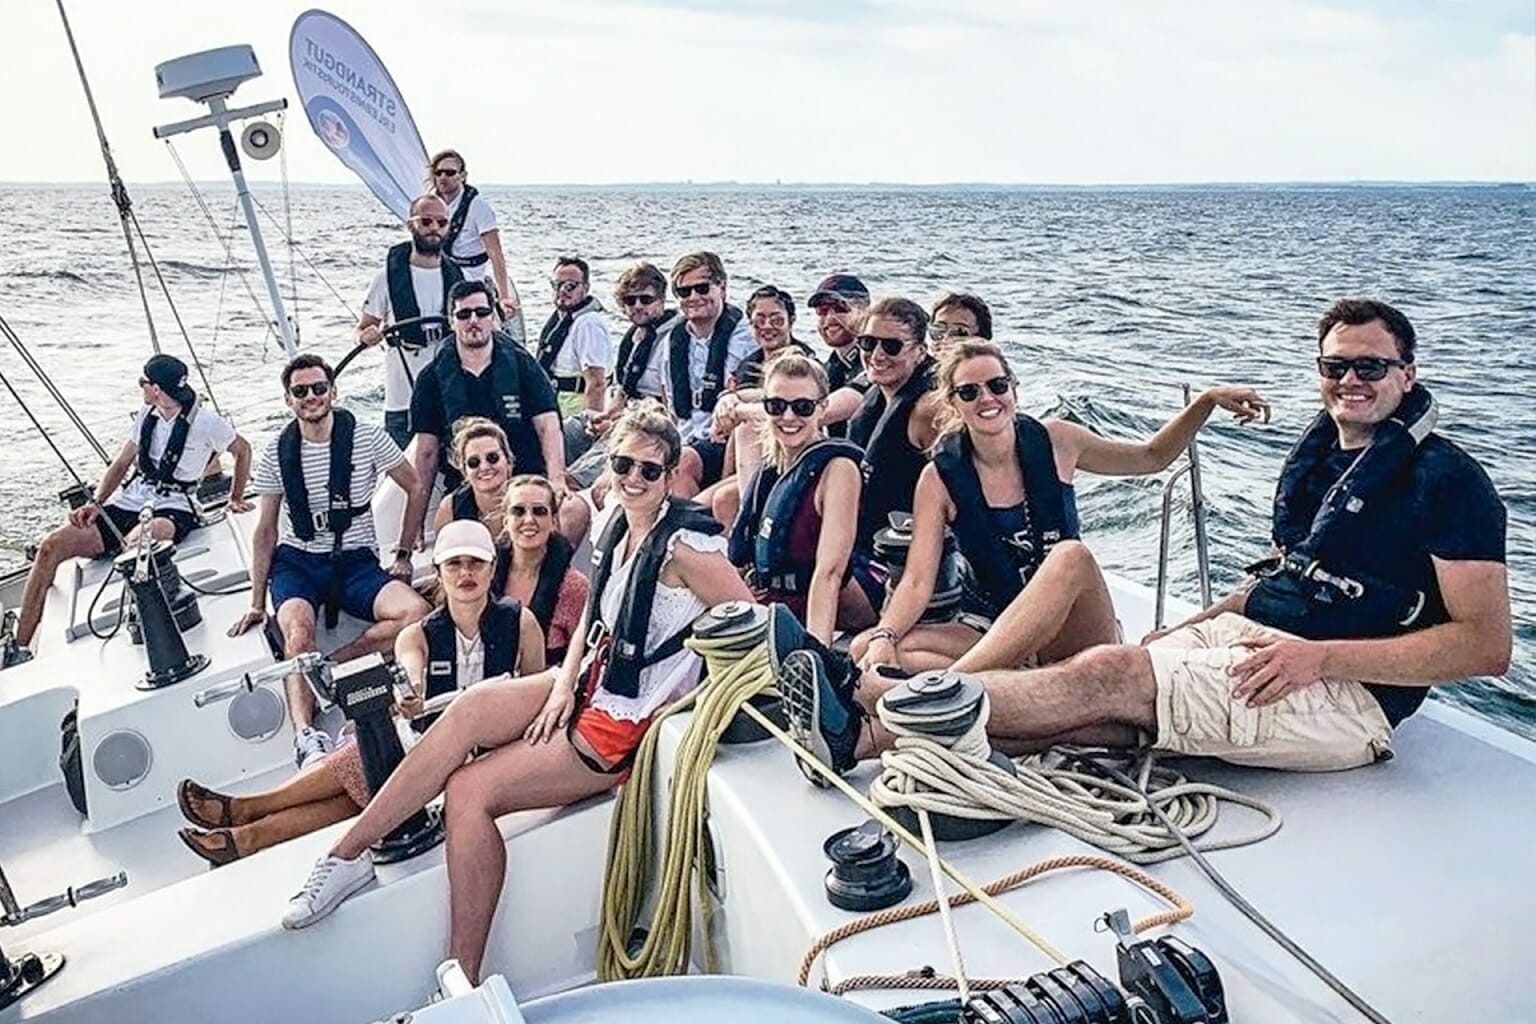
{"left": 1246, "top": 385, "right": 1438, "bottom": 639}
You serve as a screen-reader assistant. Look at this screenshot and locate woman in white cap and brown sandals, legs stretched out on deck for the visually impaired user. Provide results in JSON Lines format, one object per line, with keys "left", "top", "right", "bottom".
{"left": 177, "top": 519, "right": 544, "bottom": 867}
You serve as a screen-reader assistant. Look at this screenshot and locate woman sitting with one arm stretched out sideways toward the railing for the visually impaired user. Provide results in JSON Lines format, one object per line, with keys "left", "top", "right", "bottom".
{"left": 851, "top": 338, "right": 1269, "bottom": 672}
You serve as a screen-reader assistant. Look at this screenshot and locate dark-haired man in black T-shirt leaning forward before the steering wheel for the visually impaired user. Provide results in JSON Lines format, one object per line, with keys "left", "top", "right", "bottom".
{"left": 406, "top": 279, "right": 591, "bottom": 545}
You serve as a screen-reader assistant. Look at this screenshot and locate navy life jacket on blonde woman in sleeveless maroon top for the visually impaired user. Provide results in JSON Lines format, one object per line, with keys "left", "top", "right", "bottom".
{"left": 730, "top": 439, "right": 863, "bottom": 594}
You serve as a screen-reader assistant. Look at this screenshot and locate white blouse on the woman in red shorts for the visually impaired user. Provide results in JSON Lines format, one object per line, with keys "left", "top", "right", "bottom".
{"left": 581, "top": 530, "right": 727, "bottom": 722}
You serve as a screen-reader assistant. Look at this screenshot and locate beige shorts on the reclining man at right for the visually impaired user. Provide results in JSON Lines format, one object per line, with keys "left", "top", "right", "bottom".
{"left": 1147, "top": 613, "right": 1392, "bottom": 772}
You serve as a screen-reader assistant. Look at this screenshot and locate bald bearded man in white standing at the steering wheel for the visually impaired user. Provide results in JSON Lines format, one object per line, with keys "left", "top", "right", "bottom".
{"left": 358, "top": 195, "right": 464, "bottom": 448}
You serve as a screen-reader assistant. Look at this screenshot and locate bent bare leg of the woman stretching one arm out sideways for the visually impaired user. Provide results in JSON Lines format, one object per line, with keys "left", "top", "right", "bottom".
{"left": 952, "top": 540, "right": 1120, "bottom": 672}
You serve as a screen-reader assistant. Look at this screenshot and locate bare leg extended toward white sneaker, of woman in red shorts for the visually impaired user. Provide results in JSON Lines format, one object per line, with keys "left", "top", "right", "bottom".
{"left": 330, "top": 672, "right": 550, "bottom": 860}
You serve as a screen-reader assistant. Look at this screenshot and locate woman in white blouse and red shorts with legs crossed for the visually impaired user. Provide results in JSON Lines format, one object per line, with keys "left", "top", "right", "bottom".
{"left": 283, "top": 402, "right": 751, "bottom": 979}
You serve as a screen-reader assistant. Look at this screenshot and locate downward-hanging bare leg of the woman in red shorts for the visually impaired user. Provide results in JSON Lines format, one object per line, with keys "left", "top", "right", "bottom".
{"left": 445, "top": 734, "right": 619, "bottom": 981}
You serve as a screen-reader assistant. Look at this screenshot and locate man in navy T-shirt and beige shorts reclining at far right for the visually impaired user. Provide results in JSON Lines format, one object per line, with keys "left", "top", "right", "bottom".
{"left": 774, "top": 299, "right": 1511, "bottom": 771}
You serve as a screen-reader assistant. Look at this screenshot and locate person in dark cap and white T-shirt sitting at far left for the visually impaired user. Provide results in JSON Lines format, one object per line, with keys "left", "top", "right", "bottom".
{"left": 0, "top": 355, "right": 250, "bottom": 668}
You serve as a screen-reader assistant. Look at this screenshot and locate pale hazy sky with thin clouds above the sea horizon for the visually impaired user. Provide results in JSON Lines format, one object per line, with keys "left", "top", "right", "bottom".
{"left": 0, "top": 0, "right": 1536, "bottom": 184}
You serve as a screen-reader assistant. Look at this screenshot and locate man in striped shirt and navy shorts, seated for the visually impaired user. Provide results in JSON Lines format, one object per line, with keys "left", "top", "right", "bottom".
{"left": 229, "top": 353, "right": 427, "bottom": 768}
